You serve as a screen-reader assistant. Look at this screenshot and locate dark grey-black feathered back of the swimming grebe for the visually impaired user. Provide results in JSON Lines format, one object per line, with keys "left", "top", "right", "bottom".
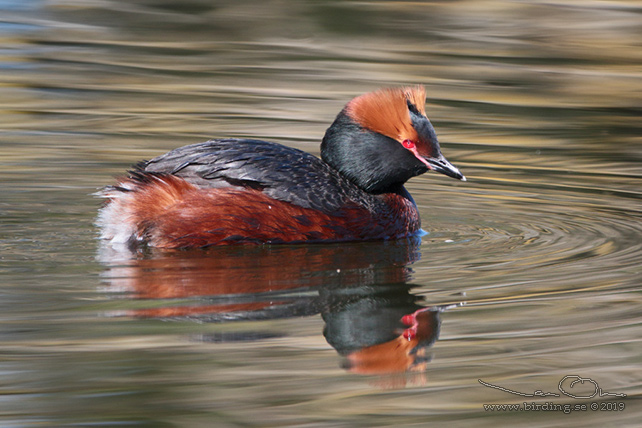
{"left": 136, "top": 138, "right": 374, "bottom": 214}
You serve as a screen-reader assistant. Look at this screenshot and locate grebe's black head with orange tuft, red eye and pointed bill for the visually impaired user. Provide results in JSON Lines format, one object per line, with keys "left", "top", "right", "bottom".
{"left": 321, "top": 86, "right": 466, "bottom": 193}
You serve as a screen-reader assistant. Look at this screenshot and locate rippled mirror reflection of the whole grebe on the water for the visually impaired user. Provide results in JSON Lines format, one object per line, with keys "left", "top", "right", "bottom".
{"left": 103, "top": 238, "right": 460, "bottom": 382}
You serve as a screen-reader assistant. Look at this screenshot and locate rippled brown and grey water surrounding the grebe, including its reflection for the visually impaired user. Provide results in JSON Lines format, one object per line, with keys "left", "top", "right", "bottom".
{"left": 0, "top": 0, "right": 642, "bottom": 427}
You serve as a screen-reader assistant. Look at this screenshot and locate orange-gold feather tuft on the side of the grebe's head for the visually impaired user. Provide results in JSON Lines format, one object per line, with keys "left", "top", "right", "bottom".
{"left": 346, "top": 86, "right": 426, "bottom": 142}
